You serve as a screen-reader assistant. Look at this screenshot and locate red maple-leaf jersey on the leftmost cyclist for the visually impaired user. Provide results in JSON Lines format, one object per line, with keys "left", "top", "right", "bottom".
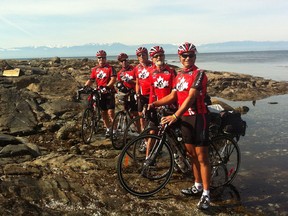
{"left": 90, "top": 64, "right": 117, "bottom": 88}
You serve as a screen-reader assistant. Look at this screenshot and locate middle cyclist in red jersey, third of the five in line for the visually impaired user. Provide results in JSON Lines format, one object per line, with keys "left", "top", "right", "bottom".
{"left": 134, "top": 47, "right": 152, "bottom": 131}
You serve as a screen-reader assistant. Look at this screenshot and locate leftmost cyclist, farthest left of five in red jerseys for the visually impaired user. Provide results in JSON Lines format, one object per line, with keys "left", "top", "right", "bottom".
{"left": 85, "top": 50, "right": 117, "bottom": 138}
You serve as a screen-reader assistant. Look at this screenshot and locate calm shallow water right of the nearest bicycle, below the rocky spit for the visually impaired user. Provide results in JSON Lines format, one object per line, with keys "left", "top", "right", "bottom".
{"left": 218, "top": 95, "right": 288, "bottom": 215}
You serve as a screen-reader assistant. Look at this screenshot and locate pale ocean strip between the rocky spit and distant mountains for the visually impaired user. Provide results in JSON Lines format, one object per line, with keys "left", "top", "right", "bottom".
{"left": 166, "top": 50, "right": 288, "bottom": 81}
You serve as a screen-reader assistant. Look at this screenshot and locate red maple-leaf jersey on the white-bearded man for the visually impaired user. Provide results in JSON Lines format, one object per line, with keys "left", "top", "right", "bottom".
{"left": 149, "top": 65, "right": 176, "bottom": 103}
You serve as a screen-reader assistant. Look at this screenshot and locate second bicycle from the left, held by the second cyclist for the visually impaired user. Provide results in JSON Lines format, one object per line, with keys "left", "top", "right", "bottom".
{"left": 110, "top": 89, "right": 142, "bottom": 150}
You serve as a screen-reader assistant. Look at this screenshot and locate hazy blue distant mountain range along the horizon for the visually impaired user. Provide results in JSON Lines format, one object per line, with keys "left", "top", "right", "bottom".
{"left": 0, "top": 41, "right": 288, "bottom": 59}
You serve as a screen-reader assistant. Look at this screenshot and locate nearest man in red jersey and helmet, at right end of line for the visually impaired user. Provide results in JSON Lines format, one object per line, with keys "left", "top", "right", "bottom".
{"left": 148, "top": 42, "right": 211, "bottom": 209}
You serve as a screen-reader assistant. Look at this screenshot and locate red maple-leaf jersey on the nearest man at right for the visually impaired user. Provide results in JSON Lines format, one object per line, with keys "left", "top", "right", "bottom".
{"left": 175, "top": 66, "right": 207, "bottom": 116}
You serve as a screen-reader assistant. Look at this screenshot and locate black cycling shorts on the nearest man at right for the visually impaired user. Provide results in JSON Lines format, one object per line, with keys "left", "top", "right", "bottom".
{"left": 181, "top": 114, "right": 209, "bottom": 146}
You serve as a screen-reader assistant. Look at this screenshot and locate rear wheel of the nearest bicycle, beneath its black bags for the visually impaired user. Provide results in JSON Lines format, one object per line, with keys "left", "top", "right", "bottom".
{"left": 210, "top": 135, "right": 241, "bottom": 186}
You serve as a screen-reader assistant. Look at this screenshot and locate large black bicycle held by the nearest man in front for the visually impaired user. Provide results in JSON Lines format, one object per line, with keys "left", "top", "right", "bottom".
{"left": 117, "top": 108, "right": 240, "bottom": 197}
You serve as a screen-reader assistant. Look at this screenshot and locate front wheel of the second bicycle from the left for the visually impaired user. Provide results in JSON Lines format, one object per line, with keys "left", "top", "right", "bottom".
{"left": 111, "top": 111, "right": 128, "bottom": 150}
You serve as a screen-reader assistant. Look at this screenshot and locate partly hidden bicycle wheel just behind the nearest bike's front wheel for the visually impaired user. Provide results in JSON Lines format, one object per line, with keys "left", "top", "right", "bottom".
{"left": 122, "top": 116, "right": 143, "bottom": 148}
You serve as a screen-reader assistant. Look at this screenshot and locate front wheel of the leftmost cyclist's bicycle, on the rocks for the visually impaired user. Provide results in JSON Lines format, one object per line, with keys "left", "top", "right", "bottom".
{"left": 81, "top": 108, "right": 95, "bottom": 144}
